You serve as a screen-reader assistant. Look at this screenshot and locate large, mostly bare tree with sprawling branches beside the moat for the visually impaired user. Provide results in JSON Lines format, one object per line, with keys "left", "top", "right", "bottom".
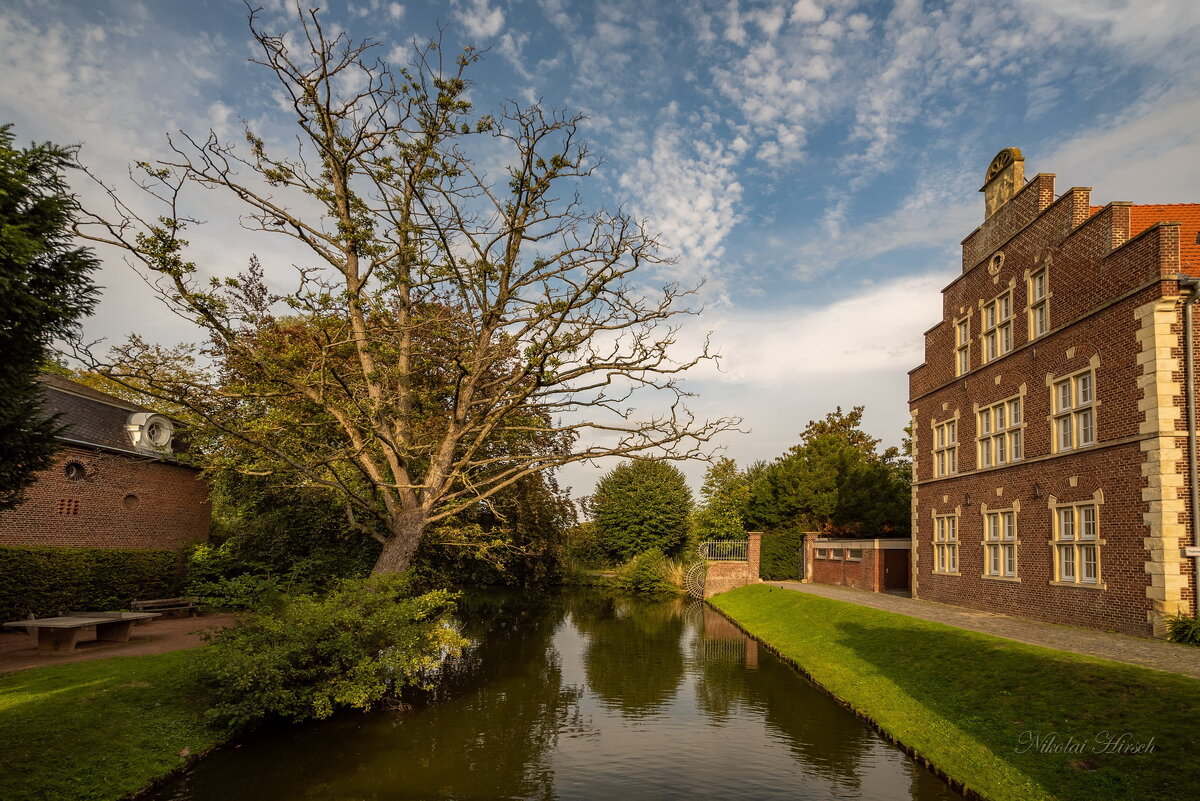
{"left": 80, "top": 6, "right": 736, "bottom": 572}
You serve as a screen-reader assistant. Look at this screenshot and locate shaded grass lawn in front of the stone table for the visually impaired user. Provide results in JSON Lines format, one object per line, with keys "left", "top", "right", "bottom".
{"left": 0, "top": 651, "right": 223, "bottom": 801}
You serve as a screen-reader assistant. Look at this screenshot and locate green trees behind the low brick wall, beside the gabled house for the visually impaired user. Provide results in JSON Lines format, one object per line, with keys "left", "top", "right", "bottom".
{"left": 746, "top": 406, "right": 911, "bottom": 536}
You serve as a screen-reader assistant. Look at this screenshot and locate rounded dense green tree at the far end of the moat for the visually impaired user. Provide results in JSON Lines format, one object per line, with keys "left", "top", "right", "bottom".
{"left": 592, "top": 460, "right": 691, "bottom": 562}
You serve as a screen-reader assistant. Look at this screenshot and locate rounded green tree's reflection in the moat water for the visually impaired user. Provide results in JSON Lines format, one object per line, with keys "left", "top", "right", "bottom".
{"left": 570, "top": 594, "right": 684, "bottom": 718}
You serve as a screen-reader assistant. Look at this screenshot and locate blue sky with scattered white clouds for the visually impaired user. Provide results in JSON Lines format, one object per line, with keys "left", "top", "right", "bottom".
{"left": 0, "top": 0, "right": 1200, "bottom": 495}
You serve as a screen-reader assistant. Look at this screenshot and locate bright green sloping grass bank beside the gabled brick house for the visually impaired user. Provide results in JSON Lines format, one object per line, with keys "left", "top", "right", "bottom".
{"left": 712, "top": 585, "right": 1200, "bottom": 801}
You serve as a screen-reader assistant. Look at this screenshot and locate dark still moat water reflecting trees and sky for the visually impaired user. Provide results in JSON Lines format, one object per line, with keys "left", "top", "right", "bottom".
{"left": 149, "top": 591, "right": 960, "bottom": 801}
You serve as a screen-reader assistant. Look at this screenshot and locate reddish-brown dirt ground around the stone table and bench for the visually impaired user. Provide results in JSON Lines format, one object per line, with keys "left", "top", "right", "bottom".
{"left": 0, "top": 615, "right": 234, "bottom": 673}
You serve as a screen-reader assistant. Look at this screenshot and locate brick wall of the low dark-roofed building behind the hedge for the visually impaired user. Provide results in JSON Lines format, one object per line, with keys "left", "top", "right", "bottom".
{"left": 0, "top": 446, "right": 211, "bottom": 549}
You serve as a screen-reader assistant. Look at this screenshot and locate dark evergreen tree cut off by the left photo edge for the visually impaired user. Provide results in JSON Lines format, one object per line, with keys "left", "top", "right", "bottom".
{"left": 0, "top": 125, "right": 97, "bottom": 510}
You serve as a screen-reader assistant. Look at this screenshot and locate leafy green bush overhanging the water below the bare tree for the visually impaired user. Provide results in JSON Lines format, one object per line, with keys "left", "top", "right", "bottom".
{"left": 199, "top": 574, "right": 467, "bottom": 729}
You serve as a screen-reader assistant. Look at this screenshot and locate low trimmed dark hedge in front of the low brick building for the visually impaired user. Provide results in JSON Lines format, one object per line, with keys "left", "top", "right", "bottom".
{"left": 0, "top": 547, "right": 184, "bottom": 622}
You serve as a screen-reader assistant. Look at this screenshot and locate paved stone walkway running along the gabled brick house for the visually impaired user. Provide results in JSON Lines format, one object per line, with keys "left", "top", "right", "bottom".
{"left": 766, "top": 582, "right": 1200, "bottom": 679}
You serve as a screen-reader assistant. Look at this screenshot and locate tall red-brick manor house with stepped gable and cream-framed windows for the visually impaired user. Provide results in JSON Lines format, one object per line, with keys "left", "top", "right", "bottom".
{"left": 910, "top": 147, "right": 1200, "bottom": 636}
